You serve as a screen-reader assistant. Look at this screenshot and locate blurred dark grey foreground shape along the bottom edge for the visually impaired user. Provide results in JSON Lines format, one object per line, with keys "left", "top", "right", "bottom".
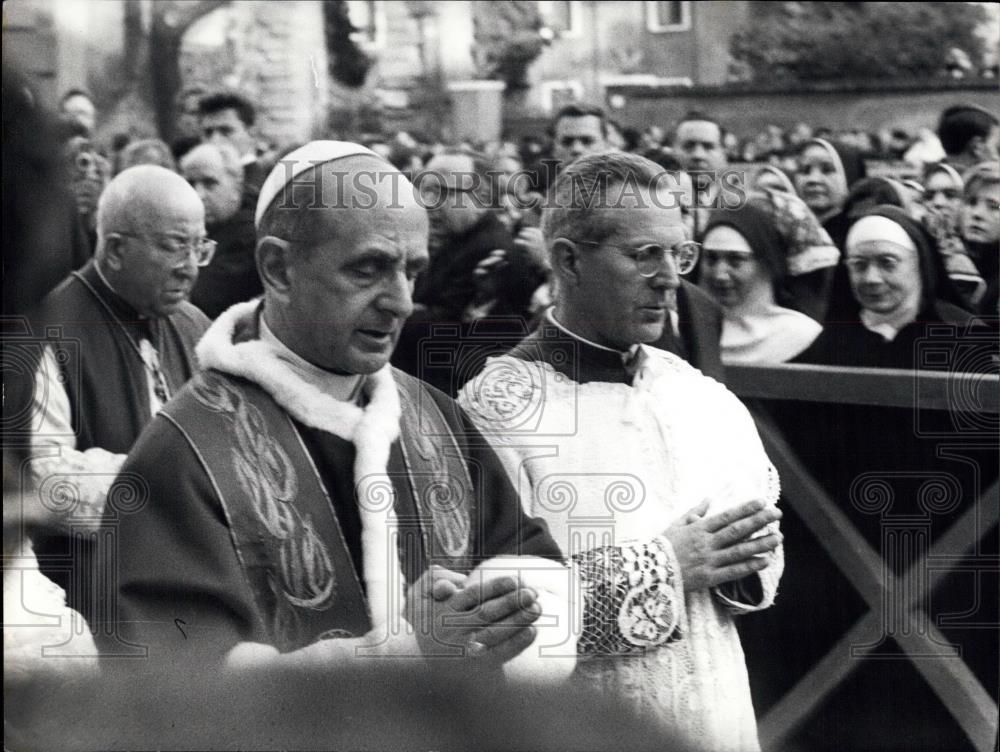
{"left": 4, "top": 656, "right": 689, "bottom": 752}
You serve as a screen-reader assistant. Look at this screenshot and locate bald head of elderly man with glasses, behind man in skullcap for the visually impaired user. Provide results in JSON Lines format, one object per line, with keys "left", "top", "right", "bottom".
{"left": 96, "top": 165, "right": 205, "bottom": 317}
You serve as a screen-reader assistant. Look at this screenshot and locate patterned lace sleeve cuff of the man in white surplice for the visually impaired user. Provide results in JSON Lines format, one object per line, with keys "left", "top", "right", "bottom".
{"left": 573, "top": 537, "right": 684, "bottom": 655}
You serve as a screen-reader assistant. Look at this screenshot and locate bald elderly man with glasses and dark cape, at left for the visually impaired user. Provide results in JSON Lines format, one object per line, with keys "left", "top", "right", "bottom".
{"left": 23, "top": 165, "right": 215, "bottom": 629}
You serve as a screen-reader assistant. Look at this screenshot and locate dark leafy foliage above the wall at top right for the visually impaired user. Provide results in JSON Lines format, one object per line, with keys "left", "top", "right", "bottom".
{"left": 730, "top": 2, "right": 986, "bottom": 81}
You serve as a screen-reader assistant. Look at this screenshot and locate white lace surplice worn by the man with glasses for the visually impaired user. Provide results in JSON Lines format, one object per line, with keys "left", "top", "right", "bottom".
{"left": 459, "top": 348, "right": 783, "bottom": 752}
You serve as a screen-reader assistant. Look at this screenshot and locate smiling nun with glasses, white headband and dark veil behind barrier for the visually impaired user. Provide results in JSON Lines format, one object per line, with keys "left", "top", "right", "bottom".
{"left": 797, "top": 206, "right": 972, "bottom": 368}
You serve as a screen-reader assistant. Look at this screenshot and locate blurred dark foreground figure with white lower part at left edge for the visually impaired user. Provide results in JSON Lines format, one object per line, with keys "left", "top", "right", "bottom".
{"left": 0, "top": 70, "right": 97, "bottom": 749}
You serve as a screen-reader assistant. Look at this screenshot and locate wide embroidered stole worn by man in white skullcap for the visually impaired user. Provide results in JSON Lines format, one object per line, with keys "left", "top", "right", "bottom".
{"left": 164, "top": 371, "right": 476, "bottom": 651}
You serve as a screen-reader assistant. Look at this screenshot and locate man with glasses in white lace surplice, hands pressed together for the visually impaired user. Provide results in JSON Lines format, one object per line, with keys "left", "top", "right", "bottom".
{"left": 459, "top": 152, "right": 783, "bottom": 752}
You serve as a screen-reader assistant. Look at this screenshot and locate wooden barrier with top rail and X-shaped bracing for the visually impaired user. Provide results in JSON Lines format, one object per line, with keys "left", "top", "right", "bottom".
{"left": 726, "top": 365, "right": 1000, "bottom": 752}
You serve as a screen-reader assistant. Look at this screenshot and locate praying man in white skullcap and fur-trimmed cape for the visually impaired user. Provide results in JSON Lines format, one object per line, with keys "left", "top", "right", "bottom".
{"left": 104, "top": 141, "right": 575, "bottom": 678}
